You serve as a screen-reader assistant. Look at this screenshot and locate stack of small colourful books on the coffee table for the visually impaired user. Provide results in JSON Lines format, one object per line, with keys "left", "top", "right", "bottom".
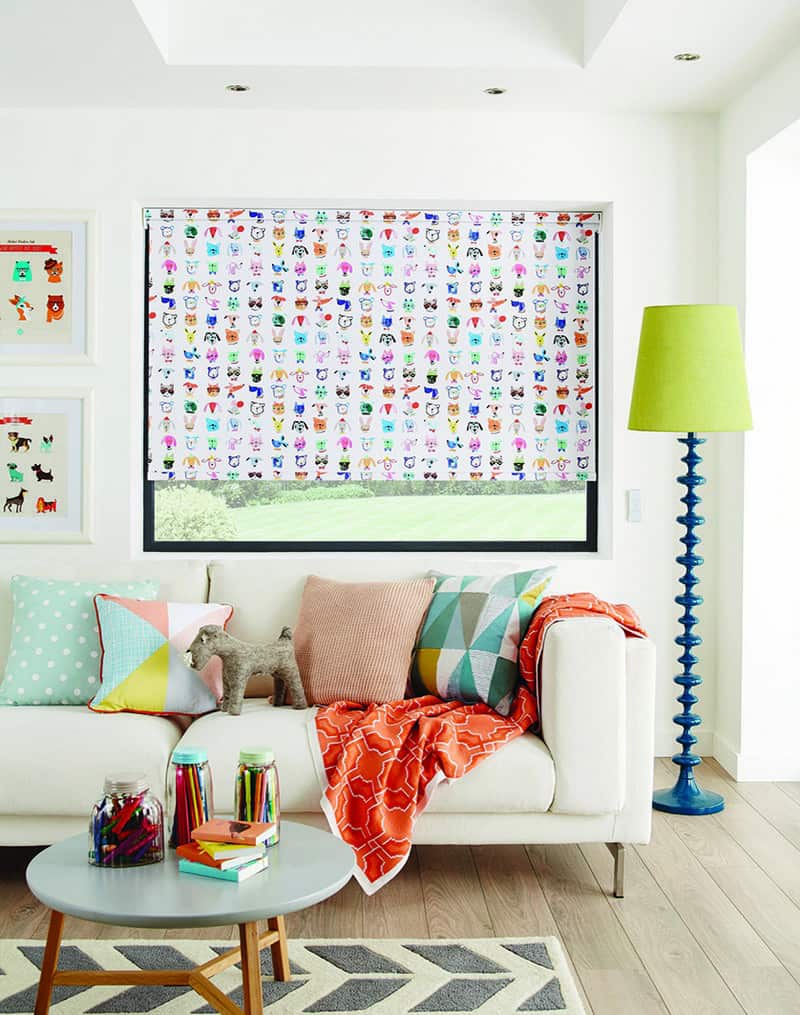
{"left": 177, "top": 818, "right": 274, "bottom": 882}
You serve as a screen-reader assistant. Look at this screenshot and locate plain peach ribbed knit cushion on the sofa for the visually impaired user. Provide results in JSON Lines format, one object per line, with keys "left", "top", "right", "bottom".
{"left": 294, "top": 574, "right": 436, "bottom": 704}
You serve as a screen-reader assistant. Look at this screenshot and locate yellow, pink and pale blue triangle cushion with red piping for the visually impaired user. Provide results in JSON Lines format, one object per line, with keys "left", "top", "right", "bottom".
{"left": 89, "top": 595, "right": 234, "bottom": 716}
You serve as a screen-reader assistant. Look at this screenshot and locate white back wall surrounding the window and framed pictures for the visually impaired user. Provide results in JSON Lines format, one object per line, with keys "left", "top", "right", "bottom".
{"left": 0, "top": 109, "right": 717, "bottom": 754}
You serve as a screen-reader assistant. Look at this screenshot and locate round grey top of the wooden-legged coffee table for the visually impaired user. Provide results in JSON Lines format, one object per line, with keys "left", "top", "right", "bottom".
{"left": 26, "top": 821, "right": 355, "bottom": 928}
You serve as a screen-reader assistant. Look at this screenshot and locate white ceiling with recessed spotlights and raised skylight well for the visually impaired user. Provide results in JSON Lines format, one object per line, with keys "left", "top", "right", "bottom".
{"left": 0, "top": 0, "right": 800, "bottom": 112}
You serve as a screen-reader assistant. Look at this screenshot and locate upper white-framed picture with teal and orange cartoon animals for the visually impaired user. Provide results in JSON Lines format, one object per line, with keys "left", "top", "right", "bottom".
{"left": 0, "top": 211, "right": 95, "bottom": 363}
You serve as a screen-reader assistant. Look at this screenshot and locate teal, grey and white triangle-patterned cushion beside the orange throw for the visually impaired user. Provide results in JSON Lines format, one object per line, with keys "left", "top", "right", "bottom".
{"left": 411, "top": 567, "right": 555, "bottom": 716}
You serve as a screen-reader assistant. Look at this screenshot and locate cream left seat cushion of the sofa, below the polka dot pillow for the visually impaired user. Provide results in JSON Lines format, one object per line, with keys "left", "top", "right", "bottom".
{"left": 0, "top": 705, "right": 181, "bottom": 816}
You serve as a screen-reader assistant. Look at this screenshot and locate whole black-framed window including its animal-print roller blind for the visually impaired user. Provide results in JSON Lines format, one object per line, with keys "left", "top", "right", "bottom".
{"left": 144, "top": 209, "right": 598, "bottom": 552}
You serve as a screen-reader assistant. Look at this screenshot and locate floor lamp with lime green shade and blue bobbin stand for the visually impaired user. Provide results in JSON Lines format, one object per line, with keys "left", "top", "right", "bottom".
{"left": 628, "top": 303, "right": 752, "bottom": 814}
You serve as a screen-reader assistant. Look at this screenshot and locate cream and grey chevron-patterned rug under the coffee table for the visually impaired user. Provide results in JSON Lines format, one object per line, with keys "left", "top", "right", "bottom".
{"left": 0, "top": 938, "right": 585, "bottom": 1015}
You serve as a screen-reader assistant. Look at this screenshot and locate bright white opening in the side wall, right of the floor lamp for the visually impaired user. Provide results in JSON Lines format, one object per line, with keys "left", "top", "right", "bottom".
{"left": 740, "top": 132, "right": 800, "bottom": 780}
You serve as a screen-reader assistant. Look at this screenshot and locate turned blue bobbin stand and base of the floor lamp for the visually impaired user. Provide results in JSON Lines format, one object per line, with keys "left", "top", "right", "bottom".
{"left": 653, "top": 433, "right": 725, "bottom": 814}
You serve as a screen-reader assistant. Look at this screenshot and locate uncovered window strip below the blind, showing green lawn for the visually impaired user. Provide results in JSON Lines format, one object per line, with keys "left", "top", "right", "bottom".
{"left": 145, "top": 480, "right": 597, "bottom": 552}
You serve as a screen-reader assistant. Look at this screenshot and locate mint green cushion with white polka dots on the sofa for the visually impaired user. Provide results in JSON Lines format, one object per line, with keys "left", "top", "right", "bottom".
{"left": 0, "top": 574, "right": 158, "bottom": 705}
